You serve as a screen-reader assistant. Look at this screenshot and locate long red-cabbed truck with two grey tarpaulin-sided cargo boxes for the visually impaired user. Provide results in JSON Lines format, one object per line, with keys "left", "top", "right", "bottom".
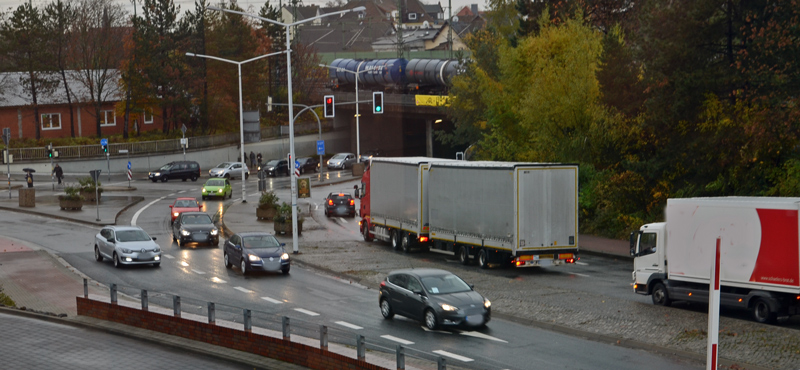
{"left": 357, "top": 157, "right": 578, "bottom": 268}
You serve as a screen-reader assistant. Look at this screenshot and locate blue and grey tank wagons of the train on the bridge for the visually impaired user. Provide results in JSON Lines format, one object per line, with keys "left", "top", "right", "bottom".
{"left": 329, "top": 58, "right": 464, "bottom": 94}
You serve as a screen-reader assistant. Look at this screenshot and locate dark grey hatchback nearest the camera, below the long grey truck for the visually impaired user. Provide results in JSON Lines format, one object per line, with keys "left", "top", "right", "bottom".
{"left": 378, "top": 269, "right": 492, "bottom": 330}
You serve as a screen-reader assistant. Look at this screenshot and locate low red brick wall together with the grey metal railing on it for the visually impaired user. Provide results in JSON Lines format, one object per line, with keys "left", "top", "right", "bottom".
{"left": 78, "top": 279, "right": 460, "bottom": 370}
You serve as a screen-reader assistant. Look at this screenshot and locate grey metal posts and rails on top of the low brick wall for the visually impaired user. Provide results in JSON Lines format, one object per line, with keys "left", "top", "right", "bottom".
{"left": 83, "top": 279, "right": 456, "bottom": 370}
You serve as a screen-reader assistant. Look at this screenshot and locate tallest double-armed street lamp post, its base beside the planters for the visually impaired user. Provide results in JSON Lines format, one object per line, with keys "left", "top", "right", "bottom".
{"left": 207, "top": 6, "right": 367, "bottom": 254}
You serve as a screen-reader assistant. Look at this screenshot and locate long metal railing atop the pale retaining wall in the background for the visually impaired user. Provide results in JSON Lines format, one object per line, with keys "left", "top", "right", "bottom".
{"left": 5, "top": 122, "right": 333, "bottom": 161}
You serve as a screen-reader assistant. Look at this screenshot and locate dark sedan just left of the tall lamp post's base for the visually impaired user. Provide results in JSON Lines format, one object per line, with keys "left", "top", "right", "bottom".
{"left": 223, "top": 232, "right": 292, "bottom": 275}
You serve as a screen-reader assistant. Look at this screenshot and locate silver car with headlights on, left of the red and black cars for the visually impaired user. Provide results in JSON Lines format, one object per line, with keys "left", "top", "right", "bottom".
{"left": 94, "top": 226, "right": 161, "bottom": 267}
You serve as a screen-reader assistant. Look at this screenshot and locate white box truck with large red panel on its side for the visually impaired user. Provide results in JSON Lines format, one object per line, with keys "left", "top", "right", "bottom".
{"left": 630, "top": 197, "right": 800, "bottom": 323}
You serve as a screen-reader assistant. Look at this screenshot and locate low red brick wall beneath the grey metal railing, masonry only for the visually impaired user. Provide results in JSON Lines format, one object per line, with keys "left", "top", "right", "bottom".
{"left": 76, "top": 297, "right": 388, "bottom": 370}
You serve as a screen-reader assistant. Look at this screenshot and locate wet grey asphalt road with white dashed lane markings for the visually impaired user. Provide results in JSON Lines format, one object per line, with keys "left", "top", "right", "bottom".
{"left": 0, "top": 172, "right": 701, "bottom": 369}
